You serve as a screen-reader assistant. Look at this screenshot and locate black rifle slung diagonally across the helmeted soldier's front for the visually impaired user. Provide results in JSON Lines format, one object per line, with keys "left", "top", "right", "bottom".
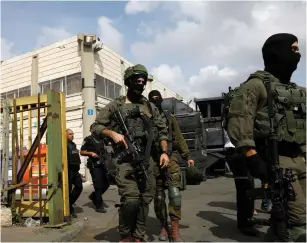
{"left": 114, "top": 109, "right": 150, "bottom": 187}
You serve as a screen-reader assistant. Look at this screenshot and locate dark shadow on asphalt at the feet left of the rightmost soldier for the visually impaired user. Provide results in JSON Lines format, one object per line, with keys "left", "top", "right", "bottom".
{"left": 197, "top": 211, "right": 263, "bottom": 242}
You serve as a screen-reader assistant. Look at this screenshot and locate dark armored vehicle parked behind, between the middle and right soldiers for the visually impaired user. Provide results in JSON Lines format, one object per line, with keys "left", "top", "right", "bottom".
{"left": 162, "top": 97, "right": 229, "bottom": 179}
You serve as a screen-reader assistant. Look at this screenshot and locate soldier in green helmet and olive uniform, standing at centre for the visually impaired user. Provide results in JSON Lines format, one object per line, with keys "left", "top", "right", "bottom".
{"left": 91, "top": 64, "right": 169, "bottom": 242}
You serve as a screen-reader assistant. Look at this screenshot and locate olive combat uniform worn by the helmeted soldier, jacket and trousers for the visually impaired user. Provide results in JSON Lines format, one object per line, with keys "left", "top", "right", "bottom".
{"left": 91, "top": 65, "right": 168, "bottom": 241}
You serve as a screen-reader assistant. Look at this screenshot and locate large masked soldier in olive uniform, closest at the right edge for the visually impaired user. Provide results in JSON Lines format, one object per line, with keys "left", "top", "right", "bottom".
{"left": 228, "top": 34, "right": 306, "bottom": 242}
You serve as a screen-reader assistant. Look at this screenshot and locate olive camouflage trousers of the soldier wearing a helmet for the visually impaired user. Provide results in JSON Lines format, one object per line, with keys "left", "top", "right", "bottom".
{"left": 115, "top": 158, "right": 156, "bottom": 239}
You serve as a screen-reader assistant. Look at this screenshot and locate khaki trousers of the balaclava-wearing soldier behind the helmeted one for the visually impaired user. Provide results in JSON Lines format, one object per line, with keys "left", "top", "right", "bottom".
{"left": 154, "top": 152, "right": 181, "bottom": 222}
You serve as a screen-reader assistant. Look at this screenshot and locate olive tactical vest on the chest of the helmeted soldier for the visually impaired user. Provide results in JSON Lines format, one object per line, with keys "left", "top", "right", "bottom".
{"left": 110, "top": 96, "right": 153, "bottom": 152}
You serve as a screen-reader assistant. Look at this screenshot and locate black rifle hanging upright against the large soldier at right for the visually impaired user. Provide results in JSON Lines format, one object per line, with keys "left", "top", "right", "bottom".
{"left": 247, "top": 77, "right": 296, "bottom": 242}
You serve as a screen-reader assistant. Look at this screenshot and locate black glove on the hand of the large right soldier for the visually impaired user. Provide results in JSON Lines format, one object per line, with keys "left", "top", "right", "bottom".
{"left": 246, "top": 154, "right": 268, "bottom": 183}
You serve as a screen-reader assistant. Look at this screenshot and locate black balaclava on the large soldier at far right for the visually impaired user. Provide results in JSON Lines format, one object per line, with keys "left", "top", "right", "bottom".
{"left": 262, "top": 33, "right": 301, "bottom": 83}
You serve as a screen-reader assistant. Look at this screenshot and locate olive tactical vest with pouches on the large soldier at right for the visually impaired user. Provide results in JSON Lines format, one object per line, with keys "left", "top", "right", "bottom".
{"left": 248, "top": 71, "right": 306, "bottom": 146}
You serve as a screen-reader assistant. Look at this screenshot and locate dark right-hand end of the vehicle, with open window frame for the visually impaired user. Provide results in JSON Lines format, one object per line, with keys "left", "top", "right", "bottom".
{"left": 194, "top": 96, "right": 229, "bottom": 177}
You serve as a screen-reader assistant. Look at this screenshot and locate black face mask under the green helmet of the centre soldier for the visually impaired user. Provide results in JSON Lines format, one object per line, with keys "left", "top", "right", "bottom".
{"left": 127, "top": 74, "right": 147, "bottom": 102}
